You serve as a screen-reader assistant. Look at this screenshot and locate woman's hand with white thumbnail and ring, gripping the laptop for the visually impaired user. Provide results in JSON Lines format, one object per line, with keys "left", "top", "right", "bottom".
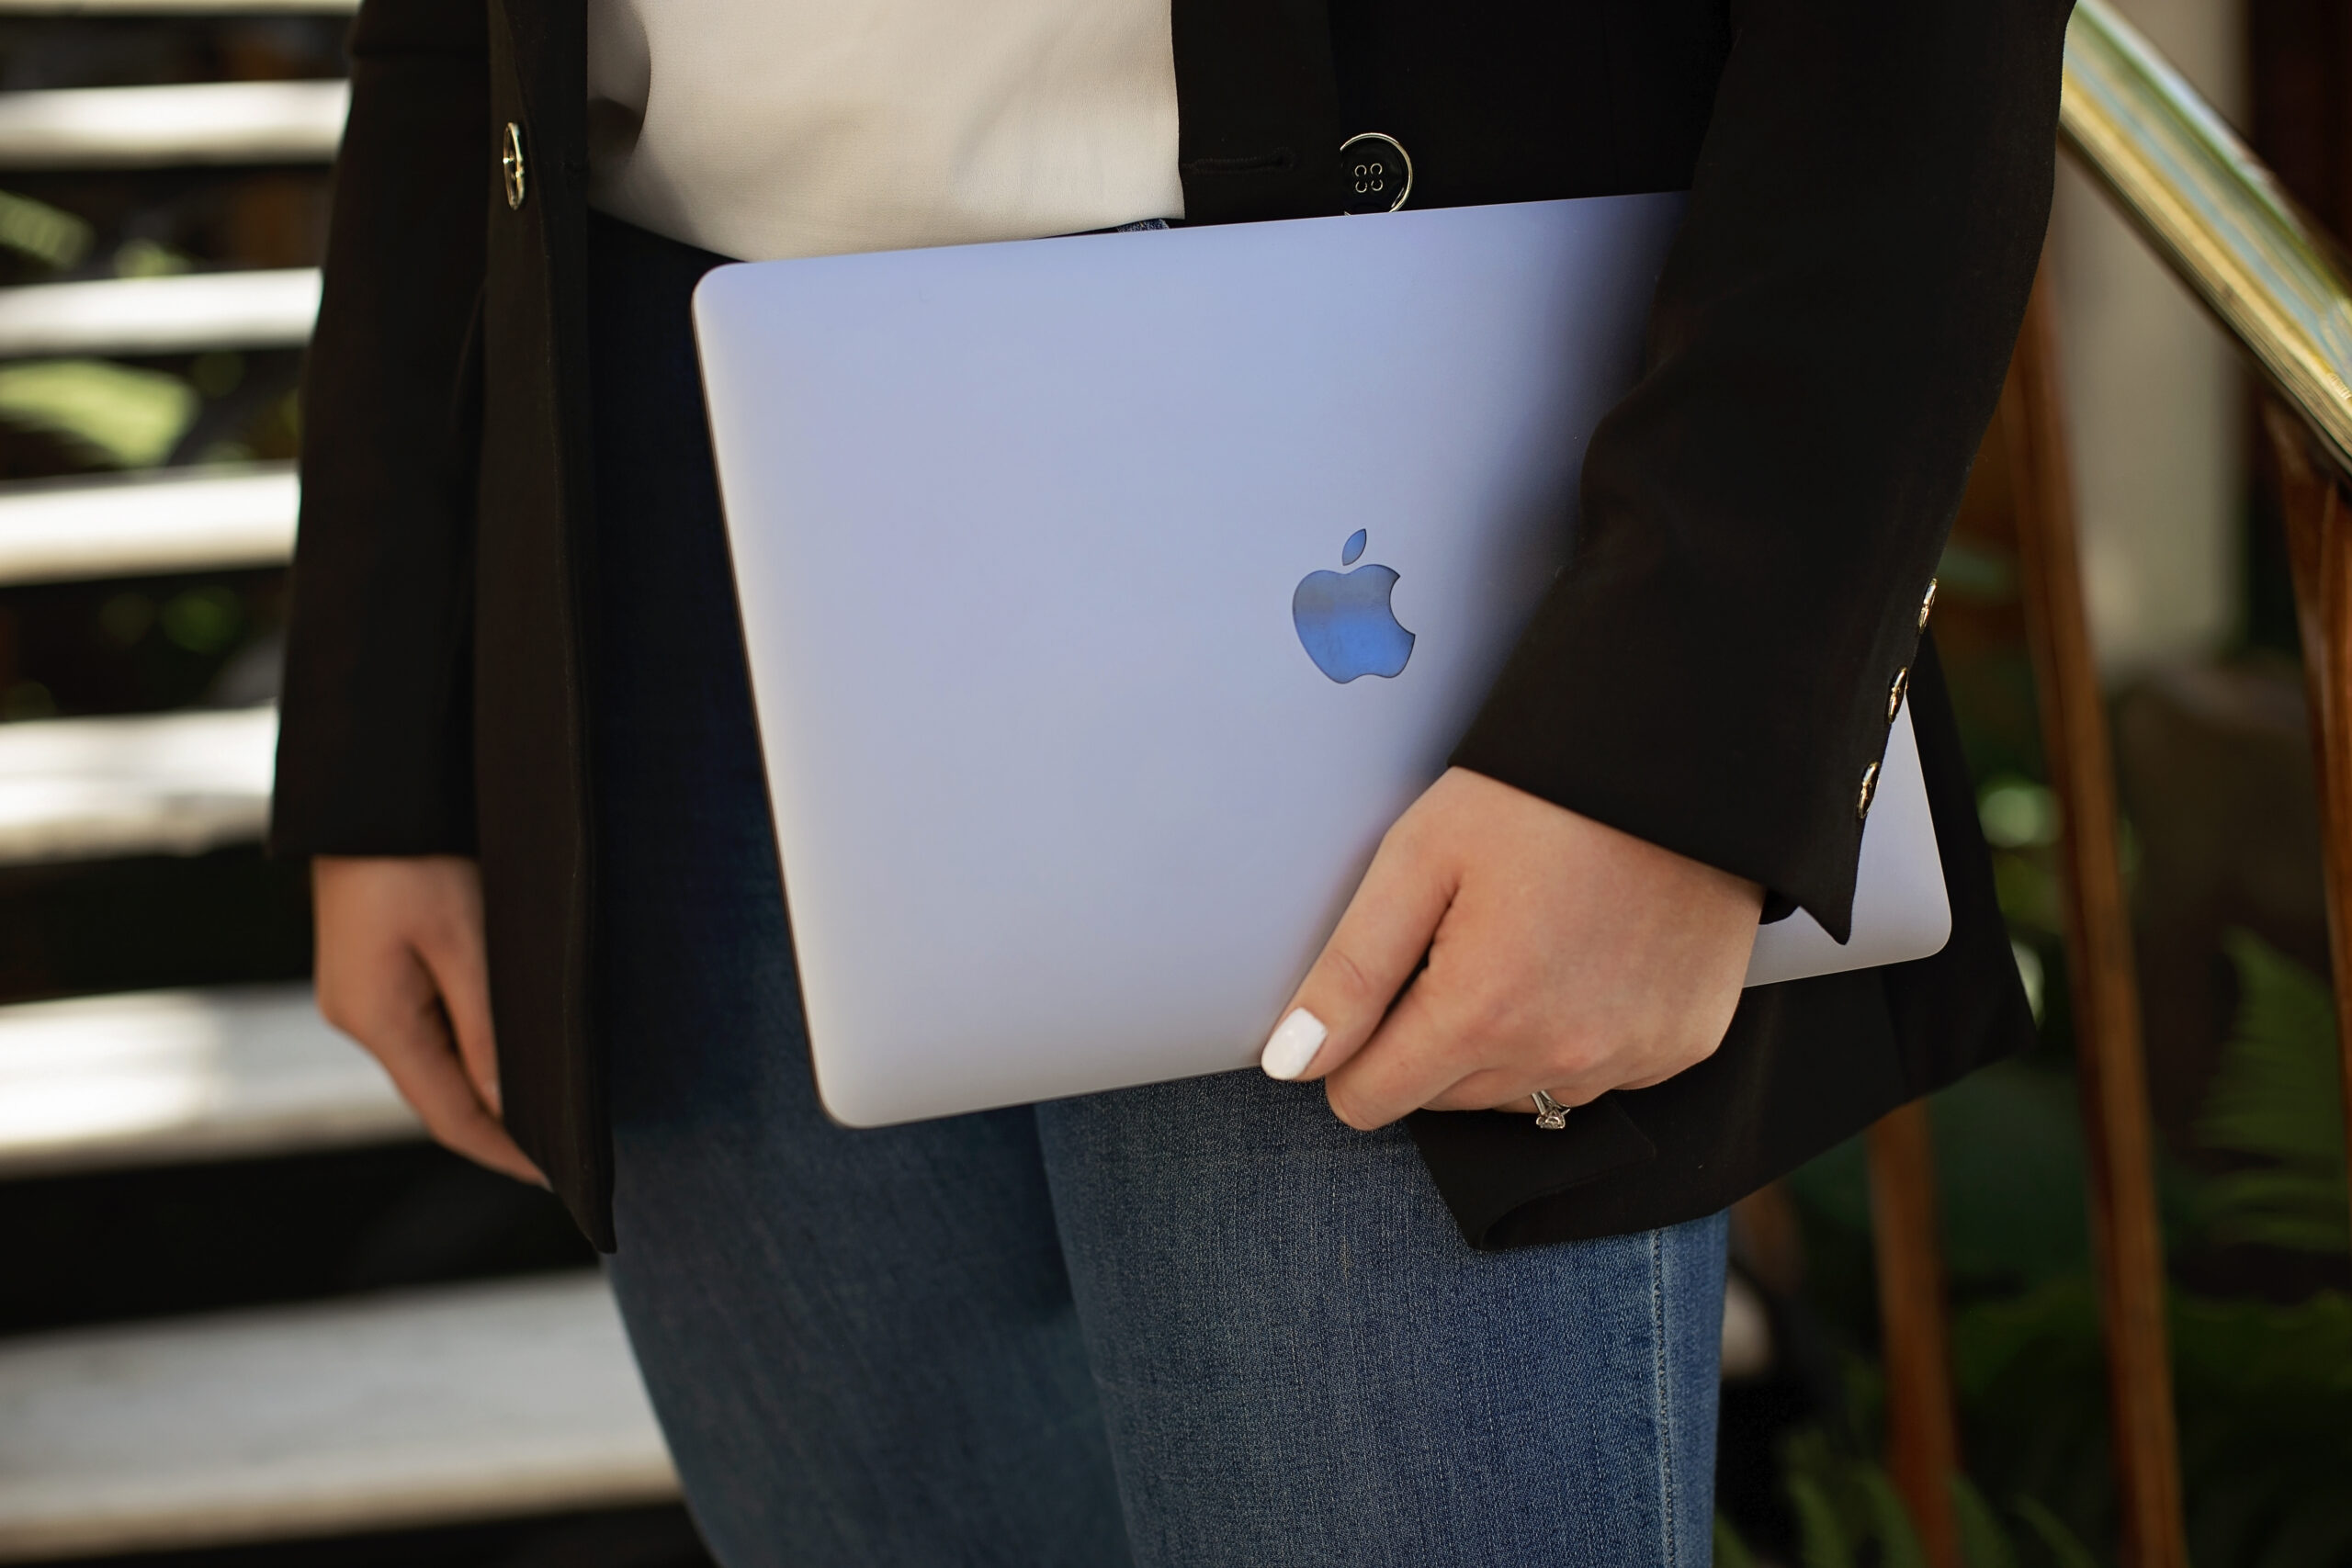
{"left": 1265, "top": 769, "right": 1764, "bottom": 1128}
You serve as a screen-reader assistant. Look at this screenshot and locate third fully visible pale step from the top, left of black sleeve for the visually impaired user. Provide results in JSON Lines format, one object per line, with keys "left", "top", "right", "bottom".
{"left": 0, "top": 463, "right": 301, "bottom": 588}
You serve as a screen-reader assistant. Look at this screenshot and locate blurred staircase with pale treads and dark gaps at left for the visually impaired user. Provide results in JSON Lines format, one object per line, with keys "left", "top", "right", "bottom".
{"left": 0, "top": 0, "right": 706, "bottom": 1568}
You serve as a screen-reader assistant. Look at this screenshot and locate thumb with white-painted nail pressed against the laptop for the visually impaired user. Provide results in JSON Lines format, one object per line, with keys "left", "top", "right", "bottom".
{"left": 1259, "top": 811, "right": 1453, "bottom": 1079}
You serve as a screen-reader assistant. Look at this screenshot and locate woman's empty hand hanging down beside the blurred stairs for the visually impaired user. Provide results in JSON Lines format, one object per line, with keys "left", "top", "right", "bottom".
{"left": 311, "top": 856, "right": 548, "bottom": 1187}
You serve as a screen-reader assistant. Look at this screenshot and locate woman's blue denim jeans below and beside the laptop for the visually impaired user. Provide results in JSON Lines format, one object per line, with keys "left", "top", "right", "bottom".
{"left": 591, "top": 219, "right": 1724, "bottom": 1568}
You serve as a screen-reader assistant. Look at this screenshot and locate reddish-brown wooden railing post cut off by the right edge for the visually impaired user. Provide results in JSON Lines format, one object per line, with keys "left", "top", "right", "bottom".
{"left": 2263, "top": 400, "right": 2352, "bottom": 1241}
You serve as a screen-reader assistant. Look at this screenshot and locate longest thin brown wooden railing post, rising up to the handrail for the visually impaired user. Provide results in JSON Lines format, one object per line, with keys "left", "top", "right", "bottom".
{"left": 2002, "top": 261, "right": 2188, "bottom": 1568}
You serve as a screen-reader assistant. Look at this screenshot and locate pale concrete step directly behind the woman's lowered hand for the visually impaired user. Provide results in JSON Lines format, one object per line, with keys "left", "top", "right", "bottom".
{"left": 0, "top": 985, "right": 421, "bottom": 1180}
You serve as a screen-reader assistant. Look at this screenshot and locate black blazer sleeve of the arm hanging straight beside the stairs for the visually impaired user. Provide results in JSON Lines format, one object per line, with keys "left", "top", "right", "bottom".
{"left": 270, "top": 0, "right": 496, "bottom": 856}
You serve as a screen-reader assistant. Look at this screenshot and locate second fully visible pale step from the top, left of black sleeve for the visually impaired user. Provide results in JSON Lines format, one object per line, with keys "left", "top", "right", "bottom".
{"left": 0, "top": 268, "right": 318, "bottom": 360}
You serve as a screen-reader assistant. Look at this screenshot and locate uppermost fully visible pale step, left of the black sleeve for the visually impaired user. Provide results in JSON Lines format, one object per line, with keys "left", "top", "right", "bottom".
{"left": 0, "top": 83, "right": 350, "bottom": 169}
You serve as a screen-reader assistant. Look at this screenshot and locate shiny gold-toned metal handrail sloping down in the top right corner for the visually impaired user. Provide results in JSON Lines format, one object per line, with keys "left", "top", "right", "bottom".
{"left": 2058, "top": 0, "right": 2352, "bottom": 472}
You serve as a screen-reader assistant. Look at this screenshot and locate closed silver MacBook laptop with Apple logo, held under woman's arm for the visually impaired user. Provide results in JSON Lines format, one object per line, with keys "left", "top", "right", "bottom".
{"left": 694, "top": 195, "right": 1950, "bottom": 1126}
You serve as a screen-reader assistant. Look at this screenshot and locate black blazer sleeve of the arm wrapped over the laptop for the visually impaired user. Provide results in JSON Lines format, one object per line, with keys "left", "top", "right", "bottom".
{"left": 1453, "top": 0, "right": 2070, "bottom": 941}
